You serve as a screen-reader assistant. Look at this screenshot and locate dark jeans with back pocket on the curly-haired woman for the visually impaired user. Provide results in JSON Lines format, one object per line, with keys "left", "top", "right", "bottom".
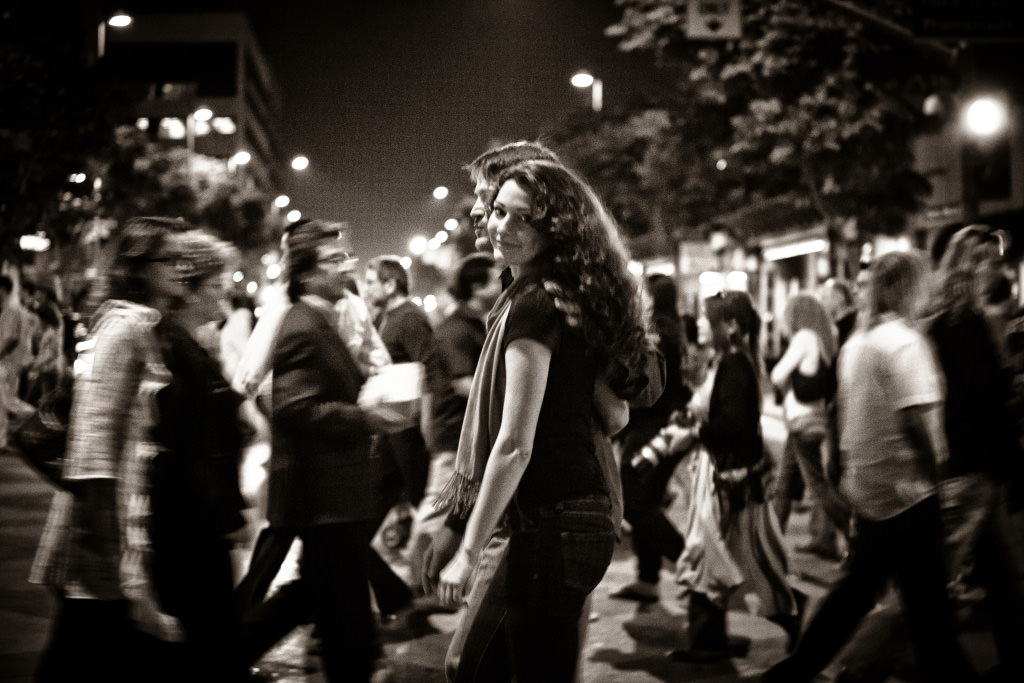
{"left": 507, "top": 497, "right": 615, "bottom": 683}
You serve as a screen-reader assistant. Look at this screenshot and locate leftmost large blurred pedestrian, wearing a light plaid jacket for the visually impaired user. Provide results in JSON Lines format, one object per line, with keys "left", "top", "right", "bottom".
{"left": 30, "top": 218, "right": 184, "bottom": 681}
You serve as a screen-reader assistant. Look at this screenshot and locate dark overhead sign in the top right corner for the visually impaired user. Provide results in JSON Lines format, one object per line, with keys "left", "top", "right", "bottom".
{"left": 913, "top": 0, "right": 1024, "bottom": 40}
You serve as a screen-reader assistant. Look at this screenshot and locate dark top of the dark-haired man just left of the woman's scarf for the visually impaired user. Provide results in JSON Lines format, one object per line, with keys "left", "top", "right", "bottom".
{"left": 428, "top": 305, "right": 486, "bottom": 452}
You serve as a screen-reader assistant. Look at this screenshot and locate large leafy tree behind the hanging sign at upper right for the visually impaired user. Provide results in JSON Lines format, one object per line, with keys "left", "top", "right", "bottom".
{"left": 589, "top": 0, "right": 954, "bottom": 272}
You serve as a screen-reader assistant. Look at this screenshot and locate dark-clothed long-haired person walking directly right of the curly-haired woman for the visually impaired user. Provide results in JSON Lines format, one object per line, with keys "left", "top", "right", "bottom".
{"left": 611, "top": 273, "right": 692, "bottom": 602}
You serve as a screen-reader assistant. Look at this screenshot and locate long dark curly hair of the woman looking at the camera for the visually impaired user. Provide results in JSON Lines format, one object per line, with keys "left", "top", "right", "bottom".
{"left": 498, "top": 160, "right": 649, "bottom": 369}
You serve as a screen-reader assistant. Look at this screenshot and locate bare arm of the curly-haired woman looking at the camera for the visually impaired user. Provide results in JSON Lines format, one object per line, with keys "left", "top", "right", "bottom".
{"left": 438, "top": 338, "right": 551, "bottom": 605}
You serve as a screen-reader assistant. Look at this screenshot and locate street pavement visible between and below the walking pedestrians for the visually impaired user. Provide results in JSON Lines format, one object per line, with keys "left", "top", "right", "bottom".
{"left": 0, "top": 414, "right": 993, "bottom": 683}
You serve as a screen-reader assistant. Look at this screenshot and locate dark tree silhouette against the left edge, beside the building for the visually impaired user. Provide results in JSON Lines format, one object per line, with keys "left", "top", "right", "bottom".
{"left": 0, "top": 7, "right": 126, "bottom": 261}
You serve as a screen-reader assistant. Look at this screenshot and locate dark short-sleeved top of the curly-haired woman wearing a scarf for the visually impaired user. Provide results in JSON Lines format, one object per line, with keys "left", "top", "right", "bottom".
{"left": 502, "top": 278, "right": 608, "bottom": 510}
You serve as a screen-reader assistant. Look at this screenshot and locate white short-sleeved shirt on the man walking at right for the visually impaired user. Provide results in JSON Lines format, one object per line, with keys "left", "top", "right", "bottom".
{"left": 838, "top": 316, "right": 945, "bottom": 520}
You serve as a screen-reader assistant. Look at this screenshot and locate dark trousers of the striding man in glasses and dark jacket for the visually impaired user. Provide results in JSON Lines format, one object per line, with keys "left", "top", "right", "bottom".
{"left": 240, "top": 521, "right": 379, "bottom": 682}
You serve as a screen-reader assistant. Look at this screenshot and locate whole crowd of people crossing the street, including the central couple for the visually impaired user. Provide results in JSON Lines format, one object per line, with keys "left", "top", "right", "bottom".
{"left": 0, "top": 141, "right": 1024, "bottom": 682}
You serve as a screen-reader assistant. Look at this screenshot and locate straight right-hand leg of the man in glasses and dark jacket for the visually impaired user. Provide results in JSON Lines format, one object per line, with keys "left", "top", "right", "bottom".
{"left": 302, "top": 522, "right": 379, "bottom": 682}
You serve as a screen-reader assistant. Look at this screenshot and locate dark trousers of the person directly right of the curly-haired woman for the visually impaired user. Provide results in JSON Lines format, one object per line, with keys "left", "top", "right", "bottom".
{"left": 621, "top": 450, "right": 685, "bottom": 584}
